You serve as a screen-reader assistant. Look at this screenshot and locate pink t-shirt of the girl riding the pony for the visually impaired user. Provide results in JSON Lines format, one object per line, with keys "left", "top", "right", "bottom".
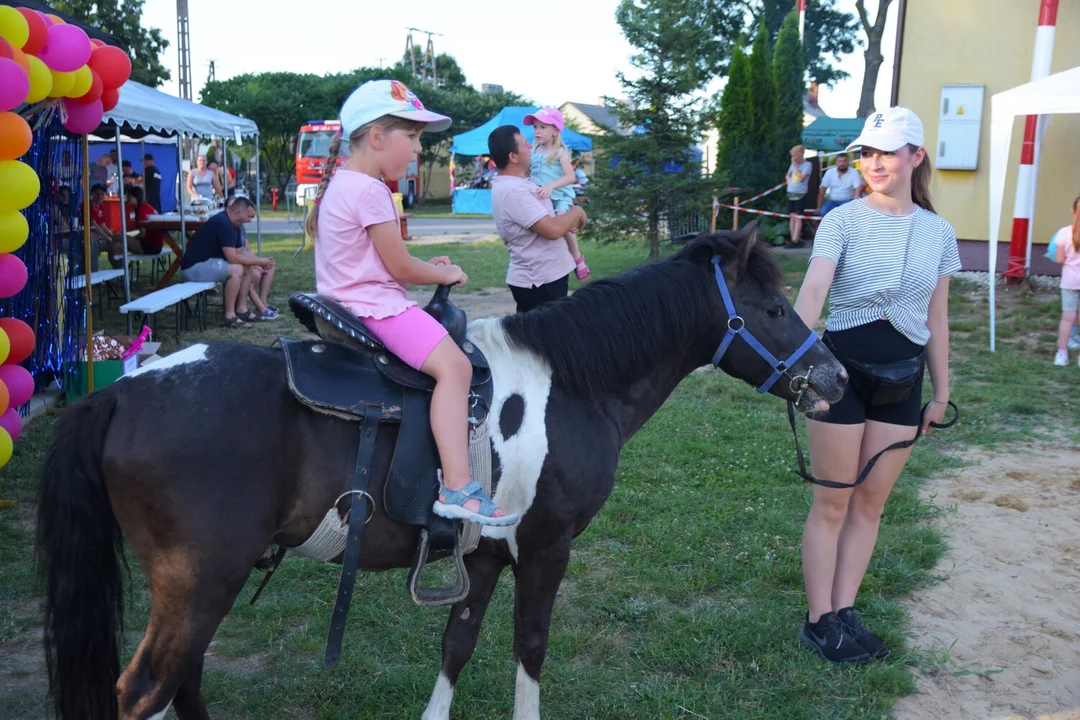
{"left": 315, "top": 167, "right": 416, "bottom": 318}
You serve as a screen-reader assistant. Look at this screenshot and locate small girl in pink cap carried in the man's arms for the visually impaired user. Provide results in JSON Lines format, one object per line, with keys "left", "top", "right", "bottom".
{"left": 523, "top": 108, "right": 590, "bottom": 281}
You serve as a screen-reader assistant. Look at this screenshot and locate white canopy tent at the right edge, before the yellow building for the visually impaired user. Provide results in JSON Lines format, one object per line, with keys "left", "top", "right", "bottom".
{"left": 987, "top": 67, "right": 1080, "bottom": 352}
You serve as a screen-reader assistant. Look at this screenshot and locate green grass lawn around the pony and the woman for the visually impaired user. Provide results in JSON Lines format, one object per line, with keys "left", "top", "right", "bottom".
{"left": 0, "top": 239, "right": 1080, "bottom": 720}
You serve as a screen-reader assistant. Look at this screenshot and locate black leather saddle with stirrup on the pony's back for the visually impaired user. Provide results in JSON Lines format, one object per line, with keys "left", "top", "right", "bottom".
{"left": 279, "top": 286, "right": 491, "bottom": 604}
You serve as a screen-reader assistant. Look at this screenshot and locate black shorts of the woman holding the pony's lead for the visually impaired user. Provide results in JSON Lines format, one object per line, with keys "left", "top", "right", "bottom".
{"left": 815, "top": 320, "right": 924, "bottom": 427}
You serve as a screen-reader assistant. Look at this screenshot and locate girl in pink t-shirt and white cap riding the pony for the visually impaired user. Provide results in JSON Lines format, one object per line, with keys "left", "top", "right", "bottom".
{"left": 308, "top": 80, "right": 518, "bottom": 526}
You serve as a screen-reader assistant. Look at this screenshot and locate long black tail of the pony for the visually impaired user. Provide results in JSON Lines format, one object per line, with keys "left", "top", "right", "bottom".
{"left": 37, "top": 392, "right": 124, "bottom": 720}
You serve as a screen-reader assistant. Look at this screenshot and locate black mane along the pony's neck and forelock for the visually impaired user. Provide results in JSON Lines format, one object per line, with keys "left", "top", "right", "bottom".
{"left": 502, "top": 228, "right": 783, "bottom": 396}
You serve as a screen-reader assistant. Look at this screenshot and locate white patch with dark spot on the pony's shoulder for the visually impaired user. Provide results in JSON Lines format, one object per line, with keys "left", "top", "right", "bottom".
{"left": 469, "top": 318, "right": 551, "bottom": 560}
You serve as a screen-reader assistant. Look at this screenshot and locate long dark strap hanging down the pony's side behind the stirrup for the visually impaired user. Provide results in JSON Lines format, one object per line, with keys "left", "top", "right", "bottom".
{"left": 323, "top": 405, "right": 382, "bottom": 668}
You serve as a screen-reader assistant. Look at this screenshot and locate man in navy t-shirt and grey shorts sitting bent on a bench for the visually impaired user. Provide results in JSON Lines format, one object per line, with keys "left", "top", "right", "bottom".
{"left": 180, "top": 198, "right": 273, "bottom": 327}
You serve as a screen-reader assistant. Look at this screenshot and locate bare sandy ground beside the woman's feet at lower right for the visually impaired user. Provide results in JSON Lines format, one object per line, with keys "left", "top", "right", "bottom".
{"left": 895, "top": 444, "right": 1080, "bottom": 720}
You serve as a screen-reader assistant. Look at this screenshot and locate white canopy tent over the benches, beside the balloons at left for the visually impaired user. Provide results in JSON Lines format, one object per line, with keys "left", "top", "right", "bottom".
{"left": 84, "top": 80, "right": 262, "bottom": 332}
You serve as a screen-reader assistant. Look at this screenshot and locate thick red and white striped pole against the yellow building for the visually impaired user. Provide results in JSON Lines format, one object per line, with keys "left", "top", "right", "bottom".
{"left": 991, "top": 0, "right": 1057, "bottom": 285}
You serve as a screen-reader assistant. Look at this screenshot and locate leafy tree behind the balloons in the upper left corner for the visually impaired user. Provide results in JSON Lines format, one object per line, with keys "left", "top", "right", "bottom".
{"left": 52, "top": 0, "right": 171, "bottom": 87}
